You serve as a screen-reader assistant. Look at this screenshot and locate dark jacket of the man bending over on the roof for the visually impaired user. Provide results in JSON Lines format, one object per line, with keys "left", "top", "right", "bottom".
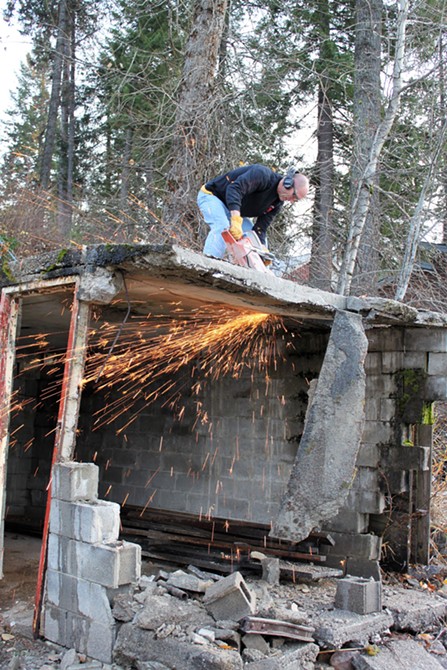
{"left": 205, "top": 164, "right": 283, "bottom": 244}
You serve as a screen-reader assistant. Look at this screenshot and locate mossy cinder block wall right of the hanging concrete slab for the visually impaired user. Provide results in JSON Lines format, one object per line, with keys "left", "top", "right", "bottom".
{"left": 325, "top": 327, "right": 447, "bottom": 576}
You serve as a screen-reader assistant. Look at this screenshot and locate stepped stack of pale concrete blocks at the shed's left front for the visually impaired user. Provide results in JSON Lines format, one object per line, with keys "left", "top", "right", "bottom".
{"left": 42, "top": 462, "right": 141, "bottom": 663}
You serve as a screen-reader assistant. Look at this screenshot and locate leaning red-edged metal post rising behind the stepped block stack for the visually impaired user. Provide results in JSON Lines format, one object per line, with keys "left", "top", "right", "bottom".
{"left": 33, "top": 285, "right": 90, "bottom": 638}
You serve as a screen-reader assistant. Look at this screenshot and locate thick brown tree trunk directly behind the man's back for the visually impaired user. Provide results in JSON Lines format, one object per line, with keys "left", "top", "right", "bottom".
{"left": 163, "top": 0, "right": 227, "bottom": 245}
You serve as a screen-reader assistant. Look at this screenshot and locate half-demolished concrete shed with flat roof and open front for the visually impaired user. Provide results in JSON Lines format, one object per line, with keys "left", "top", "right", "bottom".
{"left": 0, "top": 245, "right": 447, "bottom": 662}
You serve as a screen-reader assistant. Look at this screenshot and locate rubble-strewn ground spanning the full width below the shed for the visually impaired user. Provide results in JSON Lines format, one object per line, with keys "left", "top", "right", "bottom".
{"left": 0, "top": 532, "right": 447, "bottom": 670}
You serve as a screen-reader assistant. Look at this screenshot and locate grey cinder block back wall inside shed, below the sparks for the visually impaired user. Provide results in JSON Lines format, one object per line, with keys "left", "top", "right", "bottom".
{"left": 76, "top": 331, "right": 327, "bottom": 524}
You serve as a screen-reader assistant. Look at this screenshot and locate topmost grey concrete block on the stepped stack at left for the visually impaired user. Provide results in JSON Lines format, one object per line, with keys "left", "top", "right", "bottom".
{"left": 52, "top": 462, "right": 99, "bottom": 502}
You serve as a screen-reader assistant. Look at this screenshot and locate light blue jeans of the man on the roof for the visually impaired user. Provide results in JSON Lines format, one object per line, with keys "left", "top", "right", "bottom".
{"left": 197, "top": 191, "right": 253, "bottom": 258}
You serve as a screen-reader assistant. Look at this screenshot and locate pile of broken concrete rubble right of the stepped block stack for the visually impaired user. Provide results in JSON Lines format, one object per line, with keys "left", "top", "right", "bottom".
{"left": 112, "top": 566, "right": 447, "bottom": 670}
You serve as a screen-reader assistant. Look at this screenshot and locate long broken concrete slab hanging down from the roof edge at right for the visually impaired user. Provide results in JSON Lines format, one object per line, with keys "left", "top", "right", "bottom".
{"left": 270, "top": 312, "right": 368, "bottom": 541}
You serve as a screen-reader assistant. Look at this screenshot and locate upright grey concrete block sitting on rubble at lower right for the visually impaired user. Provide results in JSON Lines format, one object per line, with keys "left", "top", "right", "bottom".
{"left": 335, "top": 575, "right": 382, "bottom": 614}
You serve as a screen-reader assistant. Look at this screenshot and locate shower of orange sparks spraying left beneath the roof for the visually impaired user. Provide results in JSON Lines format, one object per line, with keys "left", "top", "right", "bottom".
{"left": 6, "top": 303, "right": 294, "bottom": 436}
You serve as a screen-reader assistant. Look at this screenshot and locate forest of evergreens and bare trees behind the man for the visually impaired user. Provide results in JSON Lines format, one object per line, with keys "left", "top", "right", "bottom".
{"left": 0, "top": 0, "right": 447, "bottom": 304}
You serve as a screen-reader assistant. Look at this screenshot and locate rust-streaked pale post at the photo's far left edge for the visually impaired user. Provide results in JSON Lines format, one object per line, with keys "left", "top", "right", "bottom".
{"left": 0, "top": 291, "right": 20, "bottom": 579}
